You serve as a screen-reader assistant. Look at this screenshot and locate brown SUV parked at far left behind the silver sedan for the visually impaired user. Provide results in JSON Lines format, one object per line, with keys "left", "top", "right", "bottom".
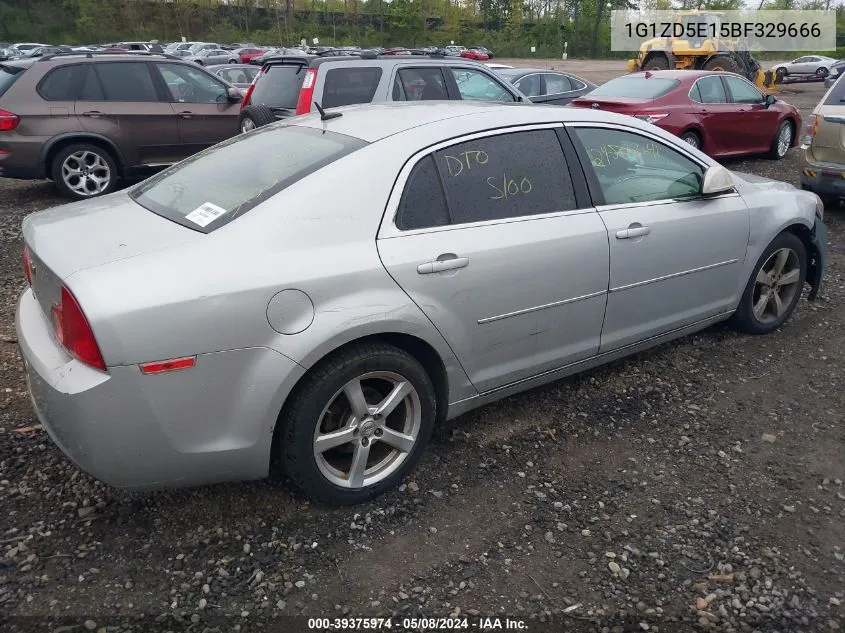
{"left": 0, "top": 53, "right": 242, "bottom": 199}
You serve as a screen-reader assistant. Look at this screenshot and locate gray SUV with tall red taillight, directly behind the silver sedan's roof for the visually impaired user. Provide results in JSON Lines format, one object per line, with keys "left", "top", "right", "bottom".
{"left": 240, "top": 54, "right": 530, "bottom": 132}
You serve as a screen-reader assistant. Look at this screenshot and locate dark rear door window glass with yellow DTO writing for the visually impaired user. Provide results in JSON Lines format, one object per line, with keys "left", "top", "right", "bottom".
{"left": 434, "top": 130, "right": 576, "bottom": 224}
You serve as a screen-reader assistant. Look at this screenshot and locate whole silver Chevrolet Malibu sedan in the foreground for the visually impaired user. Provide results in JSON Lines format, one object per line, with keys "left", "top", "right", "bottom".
{"left": 16, "top": 102, "right": 827, "bottom": 504}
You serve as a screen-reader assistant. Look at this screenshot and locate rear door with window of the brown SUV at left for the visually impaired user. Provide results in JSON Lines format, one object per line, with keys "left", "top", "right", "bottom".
{"left": 74, "top": 61, "right": 182, "bottom": 168}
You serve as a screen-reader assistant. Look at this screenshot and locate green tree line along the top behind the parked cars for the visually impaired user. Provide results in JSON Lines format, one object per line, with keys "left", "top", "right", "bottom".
{"left": 0, "top": 0, "right": 845, "bottom": 58}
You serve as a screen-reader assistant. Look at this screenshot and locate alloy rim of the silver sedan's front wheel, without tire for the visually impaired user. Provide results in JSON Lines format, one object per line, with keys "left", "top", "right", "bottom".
{"left": 752, "top": 248, "right": 801, "bottom": 324}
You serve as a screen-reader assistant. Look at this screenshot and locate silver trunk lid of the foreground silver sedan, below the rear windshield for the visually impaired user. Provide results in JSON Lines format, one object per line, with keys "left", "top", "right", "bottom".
{"left": 23, "top": 193, "right": 203, "bottom": 315}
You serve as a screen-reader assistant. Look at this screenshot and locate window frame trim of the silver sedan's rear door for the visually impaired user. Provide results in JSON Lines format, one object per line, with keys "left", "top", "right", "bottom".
{"left": 376, "top": 122, "right": 595, "bottom": 240}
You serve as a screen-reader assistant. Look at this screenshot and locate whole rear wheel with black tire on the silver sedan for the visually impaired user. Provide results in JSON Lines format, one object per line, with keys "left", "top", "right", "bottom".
{"left": 274, "top": 343, "right": 437, "bottom": 505}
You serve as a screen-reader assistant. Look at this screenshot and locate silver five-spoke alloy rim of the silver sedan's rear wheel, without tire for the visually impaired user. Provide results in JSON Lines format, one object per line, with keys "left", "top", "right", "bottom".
{"left": 313, "top": 371, "right": 422, "bottom": 488}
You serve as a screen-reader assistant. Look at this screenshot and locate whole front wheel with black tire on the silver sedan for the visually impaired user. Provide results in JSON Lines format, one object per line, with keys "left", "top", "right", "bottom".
{"left": 733, "top": 232, "right": 807, "bottom": 334}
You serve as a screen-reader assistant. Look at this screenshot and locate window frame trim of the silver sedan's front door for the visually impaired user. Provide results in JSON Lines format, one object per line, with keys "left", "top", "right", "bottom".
{"left": 564, "top": 121, "right": 739, "bottom": 212}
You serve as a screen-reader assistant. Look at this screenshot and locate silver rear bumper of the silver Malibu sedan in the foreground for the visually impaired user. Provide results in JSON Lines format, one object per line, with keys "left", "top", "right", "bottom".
{"left": 15, "top": 289, "right": 304, "bottom": 489}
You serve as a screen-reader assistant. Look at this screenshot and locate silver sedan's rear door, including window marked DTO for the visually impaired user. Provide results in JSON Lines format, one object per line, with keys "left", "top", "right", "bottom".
{"left": 377, "top": 126, "right": 608, "bottom": 392}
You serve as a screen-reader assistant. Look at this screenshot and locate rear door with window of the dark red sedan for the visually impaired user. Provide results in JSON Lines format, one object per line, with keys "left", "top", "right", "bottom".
{"left": 689, "top": 74, "right": 744, "bottom": 156}
